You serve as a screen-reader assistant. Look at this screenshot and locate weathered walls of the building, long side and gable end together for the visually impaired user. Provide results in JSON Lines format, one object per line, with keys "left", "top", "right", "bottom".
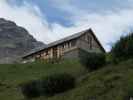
{"left": 22, "top": 32, "right": 103, "bottom": 61}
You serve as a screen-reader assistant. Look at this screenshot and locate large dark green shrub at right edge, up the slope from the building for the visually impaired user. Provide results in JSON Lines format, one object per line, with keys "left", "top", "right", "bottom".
{"left": 111, "top": 33, "right": 133, "bottom": 61}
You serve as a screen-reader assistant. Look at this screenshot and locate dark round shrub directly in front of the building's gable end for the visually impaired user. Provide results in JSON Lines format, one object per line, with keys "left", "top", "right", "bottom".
{"left": 80, "top": 49, "right": 106, "bottom": 71}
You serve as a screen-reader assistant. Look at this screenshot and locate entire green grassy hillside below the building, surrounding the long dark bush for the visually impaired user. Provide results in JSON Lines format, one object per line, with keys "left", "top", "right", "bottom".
{"left": 0, "top": 60, "right": 133, "bottom": 100}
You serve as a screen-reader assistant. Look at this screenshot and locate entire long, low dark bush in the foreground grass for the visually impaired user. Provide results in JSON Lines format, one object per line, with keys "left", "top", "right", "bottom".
{"left": 20, "top": 74, "right": 75, "bottom": 98}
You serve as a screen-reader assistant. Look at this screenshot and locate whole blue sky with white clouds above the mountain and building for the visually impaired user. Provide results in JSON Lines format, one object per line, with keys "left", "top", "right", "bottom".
{"left": 0, "top": 0, "right": 133, "bottom": 51}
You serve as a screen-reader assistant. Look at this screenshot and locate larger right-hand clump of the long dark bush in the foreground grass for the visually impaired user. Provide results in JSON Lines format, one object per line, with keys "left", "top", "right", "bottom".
{"left": 41, "top": 74, "right": 75, "bottom": 96}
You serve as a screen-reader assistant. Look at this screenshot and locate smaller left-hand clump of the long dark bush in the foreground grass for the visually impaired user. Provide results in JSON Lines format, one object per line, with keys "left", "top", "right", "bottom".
{"left": 20, "top": 81, "right": 40, "bottom": 98}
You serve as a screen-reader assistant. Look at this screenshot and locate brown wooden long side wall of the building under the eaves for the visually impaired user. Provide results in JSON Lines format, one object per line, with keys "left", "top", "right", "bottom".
{"left": 24, "top": 40, "right": 77, "bottom": 61}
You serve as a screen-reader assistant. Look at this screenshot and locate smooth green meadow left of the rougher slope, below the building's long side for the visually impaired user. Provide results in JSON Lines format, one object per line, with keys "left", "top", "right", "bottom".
{"left": 0, "top": 60, "right": 86, "bottom": 100}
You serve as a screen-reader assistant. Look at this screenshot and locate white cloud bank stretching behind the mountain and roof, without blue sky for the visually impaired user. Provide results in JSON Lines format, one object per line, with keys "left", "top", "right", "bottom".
{"left": 0, "top": 0, "right": 133, "bottom": 51}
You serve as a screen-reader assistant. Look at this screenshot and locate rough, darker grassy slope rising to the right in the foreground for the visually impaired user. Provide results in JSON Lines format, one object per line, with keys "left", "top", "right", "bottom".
{"left": 37, "top": 60, "right": 133, "bottom": 100}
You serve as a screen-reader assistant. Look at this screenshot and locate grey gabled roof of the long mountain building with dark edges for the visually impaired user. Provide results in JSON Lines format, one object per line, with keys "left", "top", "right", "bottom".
{"left": 23, "top": 29, "right": 105, "bottom": 58}
